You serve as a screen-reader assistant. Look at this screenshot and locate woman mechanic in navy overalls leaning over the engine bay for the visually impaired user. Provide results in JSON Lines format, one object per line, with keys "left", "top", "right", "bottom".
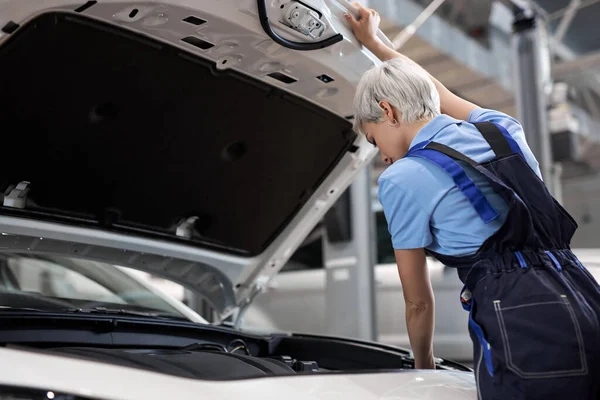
{"left": 346, "top": 3, "right": 600, "bottom": 400}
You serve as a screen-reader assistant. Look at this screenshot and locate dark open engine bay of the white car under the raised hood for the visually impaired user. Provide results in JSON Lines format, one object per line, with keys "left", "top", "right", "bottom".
{"left": 0, "top": 311, "right": 471, "bottom": 380}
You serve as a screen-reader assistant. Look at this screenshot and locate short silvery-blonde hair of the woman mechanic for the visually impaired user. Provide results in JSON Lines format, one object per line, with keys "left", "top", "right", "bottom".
{"left": 354, "top": 57, "right": 440, "bottom": 134}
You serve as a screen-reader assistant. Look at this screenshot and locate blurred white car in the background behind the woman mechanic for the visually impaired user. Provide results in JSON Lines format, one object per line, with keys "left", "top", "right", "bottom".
{"left": 241, "top": 205, "right": 600, "bottom": 363}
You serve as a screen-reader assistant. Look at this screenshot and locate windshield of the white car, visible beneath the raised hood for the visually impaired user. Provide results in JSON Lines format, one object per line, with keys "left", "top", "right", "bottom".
{"left": 0, "top": 254, "right": 189, "bottom": 319}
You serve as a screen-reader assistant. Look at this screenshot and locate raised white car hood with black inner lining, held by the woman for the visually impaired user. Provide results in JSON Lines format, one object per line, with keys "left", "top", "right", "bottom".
{"left": 0, "top": 0, "right": 389, "bottom": 320}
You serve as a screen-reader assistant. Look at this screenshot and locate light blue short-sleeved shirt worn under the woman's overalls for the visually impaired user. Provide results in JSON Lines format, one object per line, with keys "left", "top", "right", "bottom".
{"left": 378, "top": 108, "right": 541, "bottom": 256}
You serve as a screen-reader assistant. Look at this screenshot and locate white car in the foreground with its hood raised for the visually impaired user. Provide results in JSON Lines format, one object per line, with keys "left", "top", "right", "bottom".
{"left": 0, "top": 0, "right": 476, "bottom": 400}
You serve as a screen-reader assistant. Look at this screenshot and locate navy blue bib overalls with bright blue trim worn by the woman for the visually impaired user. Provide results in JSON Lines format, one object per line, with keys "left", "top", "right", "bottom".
{"left": 406, "top": 122, "right": 600, "bottom": 400}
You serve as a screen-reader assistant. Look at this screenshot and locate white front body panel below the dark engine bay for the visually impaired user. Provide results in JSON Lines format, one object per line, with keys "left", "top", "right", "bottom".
{"left": 0, "top": 348, "right": 477, "bottom": 400}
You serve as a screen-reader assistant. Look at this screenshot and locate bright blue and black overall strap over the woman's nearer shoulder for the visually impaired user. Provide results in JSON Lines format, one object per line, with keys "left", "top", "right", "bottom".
{"left": 406, "top": 142, "right": 499, "bottom": 224}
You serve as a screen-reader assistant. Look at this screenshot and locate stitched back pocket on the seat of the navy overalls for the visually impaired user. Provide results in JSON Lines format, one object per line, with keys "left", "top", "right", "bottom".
{"left": 494, "top": 295, "right": 588, "bottom": 379}
